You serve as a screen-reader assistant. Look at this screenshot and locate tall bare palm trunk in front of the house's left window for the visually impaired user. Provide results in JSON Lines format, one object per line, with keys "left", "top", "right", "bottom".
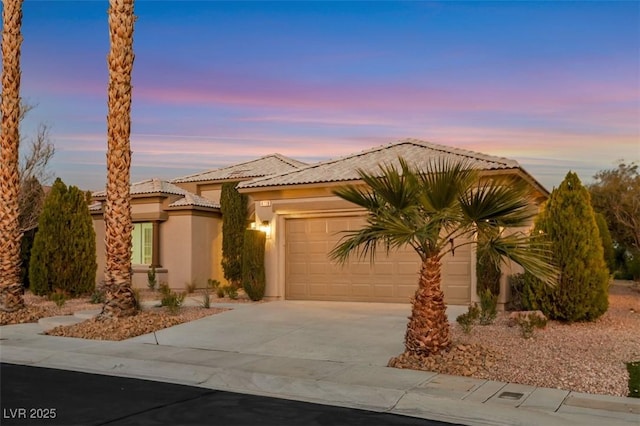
{"left": 101, "top": 0, "right": 136, "bottom": 317}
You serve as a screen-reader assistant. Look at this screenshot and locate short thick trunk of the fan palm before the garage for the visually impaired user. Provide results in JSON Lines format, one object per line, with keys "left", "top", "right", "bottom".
{"left": 404, "top": 257, "right": 451, "bottom": 356}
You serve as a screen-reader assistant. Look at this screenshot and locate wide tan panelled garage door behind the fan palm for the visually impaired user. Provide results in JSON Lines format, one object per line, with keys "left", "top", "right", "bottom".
{"left": 285, "top": 216, "right": 471, "bottom": 304}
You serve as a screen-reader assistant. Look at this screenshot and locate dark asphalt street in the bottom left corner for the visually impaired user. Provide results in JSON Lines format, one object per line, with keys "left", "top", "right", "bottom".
{"left": 0, "top": 363, "right": 460, "bottom": 426}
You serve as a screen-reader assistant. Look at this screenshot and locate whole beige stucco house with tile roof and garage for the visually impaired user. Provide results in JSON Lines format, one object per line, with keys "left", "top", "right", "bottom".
{"left": 91, "top": 139, "right": 548, "bottom": 304}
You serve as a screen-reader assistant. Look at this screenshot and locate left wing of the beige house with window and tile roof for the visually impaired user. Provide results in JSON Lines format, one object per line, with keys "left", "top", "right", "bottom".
{"left": 89, "top": 154, "right": 306, "bottom": 288}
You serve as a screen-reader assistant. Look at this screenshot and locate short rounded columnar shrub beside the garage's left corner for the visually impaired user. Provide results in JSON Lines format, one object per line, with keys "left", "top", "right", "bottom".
{"left": 242, "top": 229, "right": 267, "bottom": 301}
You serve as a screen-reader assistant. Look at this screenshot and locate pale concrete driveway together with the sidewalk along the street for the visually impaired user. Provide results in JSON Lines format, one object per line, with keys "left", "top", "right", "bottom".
{"left": 0, "top": 301, "right": 640, "bottom": 426}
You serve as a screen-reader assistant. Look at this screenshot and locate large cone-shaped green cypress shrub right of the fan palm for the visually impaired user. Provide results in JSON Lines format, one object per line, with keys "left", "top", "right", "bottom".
{"left": 523, "top": 172, "right": 609, "bottom": 322}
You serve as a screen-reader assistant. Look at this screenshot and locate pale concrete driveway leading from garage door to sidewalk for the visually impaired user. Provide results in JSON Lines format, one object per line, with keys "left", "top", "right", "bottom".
{"left": 130, "top": 301, "right": 466, "bottom": 366}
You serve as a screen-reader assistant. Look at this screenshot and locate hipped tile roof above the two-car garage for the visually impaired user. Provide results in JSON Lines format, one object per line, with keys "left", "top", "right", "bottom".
{"left": 238, "top": 139, "right": 520, "bottom": 188}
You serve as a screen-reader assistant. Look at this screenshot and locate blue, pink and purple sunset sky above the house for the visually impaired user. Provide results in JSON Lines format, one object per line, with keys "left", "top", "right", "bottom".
{"left": 13, "top": 0, "right": 640, "bottom": 190}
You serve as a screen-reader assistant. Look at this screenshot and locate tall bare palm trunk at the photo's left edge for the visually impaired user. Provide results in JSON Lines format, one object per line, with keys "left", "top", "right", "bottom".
{"left": 0, "top": 0, "right": 24, "bottom": 312}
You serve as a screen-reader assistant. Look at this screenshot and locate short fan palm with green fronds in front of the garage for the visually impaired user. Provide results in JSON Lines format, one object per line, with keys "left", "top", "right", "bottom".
{"left": 330, "top": 158, "right": 555, "bottom": 356}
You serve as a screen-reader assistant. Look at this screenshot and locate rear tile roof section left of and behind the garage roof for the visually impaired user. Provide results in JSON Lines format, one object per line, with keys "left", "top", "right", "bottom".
{"left": 171, "top": 154, "right": 307, "bottom": 183}
